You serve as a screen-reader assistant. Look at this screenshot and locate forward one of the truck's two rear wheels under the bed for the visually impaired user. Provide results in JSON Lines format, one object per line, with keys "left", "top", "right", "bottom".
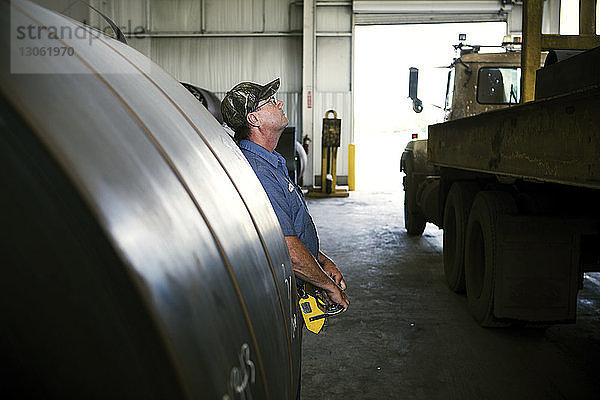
{"left": 443, "top": 182, "right": 479, "bottom": 293}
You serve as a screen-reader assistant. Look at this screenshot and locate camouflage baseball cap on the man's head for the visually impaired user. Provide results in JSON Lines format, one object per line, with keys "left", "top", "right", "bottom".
{"left": 221, "top": 78, "right": 280, "bottom": 130}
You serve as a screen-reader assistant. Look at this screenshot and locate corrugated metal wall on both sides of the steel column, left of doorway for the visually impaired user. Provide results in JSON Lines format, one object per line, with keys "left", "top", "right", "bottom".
{"left": 30, "top": 0, "right": 353, "bottom": 183}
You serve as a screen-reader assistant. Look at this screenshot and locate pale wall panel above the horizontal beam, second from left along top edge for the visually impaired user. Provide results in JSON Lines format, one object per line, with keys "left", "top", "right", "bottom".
{"left": 150, "top": 0, "right": 202, "bottom": 32}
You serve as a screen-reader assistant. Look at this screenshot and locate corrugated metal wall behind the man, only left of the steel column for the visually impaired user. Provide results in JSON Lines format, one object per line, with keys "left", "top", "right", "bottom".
{"left": 82, "top": 0, "right": 302, "bottom": 132}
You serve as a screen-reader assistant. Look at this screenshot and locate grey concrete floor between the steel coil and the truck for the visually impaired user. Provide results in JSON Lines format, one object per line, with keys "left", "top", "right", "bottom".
{"left": 302, "top": 191, "right": 600, "bottom": 400}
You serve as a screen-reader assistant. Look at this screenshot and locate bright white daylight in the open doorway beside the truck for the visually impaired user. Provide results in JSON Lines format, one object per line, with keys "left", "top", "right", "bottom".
{"left": 354, "top": 22, "right": 506, "bottom": 191}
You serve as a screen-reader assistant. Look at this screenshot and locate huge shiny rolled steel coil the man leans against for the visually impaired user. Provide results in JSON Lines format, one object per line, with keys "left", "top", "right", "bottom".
{"left": 0, "top": 0, "right": 300, "bottom": 400}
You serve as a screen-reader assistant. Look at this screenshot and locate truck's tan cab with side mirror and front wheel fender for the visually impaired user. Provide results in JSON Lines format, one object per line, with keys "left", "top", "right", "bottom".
{"left": 400, "top": 43, "right": 521, "bottom": 235}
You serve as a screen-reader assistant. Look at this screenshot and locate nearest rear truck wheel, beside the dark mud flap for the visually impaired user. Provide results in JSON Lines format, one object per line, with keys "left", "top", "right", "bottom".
{"left": 465, "top": 191, "right": 517, "bottom": 327}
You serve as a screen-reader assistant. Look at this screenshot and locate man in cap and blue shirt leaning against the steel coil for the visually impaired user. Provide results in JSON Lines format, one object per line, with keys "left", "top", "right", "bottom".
{"left": 221, "top": 78, "right": 350, "bottom": 311}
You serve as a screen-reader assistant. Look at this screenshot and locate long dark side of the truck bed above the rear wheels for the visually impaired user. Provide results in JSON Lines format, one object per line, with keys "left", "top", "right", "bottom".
{"left": 427, "top": 86, "right": 600, "bottom": 189}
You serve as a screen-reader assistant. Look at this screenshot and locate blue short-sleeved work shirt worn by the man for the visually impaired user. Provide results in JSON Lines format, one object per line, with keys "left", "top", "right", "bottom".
{"left": 240, "top": 140, "right": 319, "bottom": 260}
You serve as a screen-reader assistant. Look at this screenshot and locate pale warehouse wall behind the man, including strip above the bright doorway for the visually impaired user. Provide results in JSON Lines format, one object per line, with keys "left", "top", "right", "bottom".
{"left": 30, "top": 0, "right": 540, "bottom": 189}
